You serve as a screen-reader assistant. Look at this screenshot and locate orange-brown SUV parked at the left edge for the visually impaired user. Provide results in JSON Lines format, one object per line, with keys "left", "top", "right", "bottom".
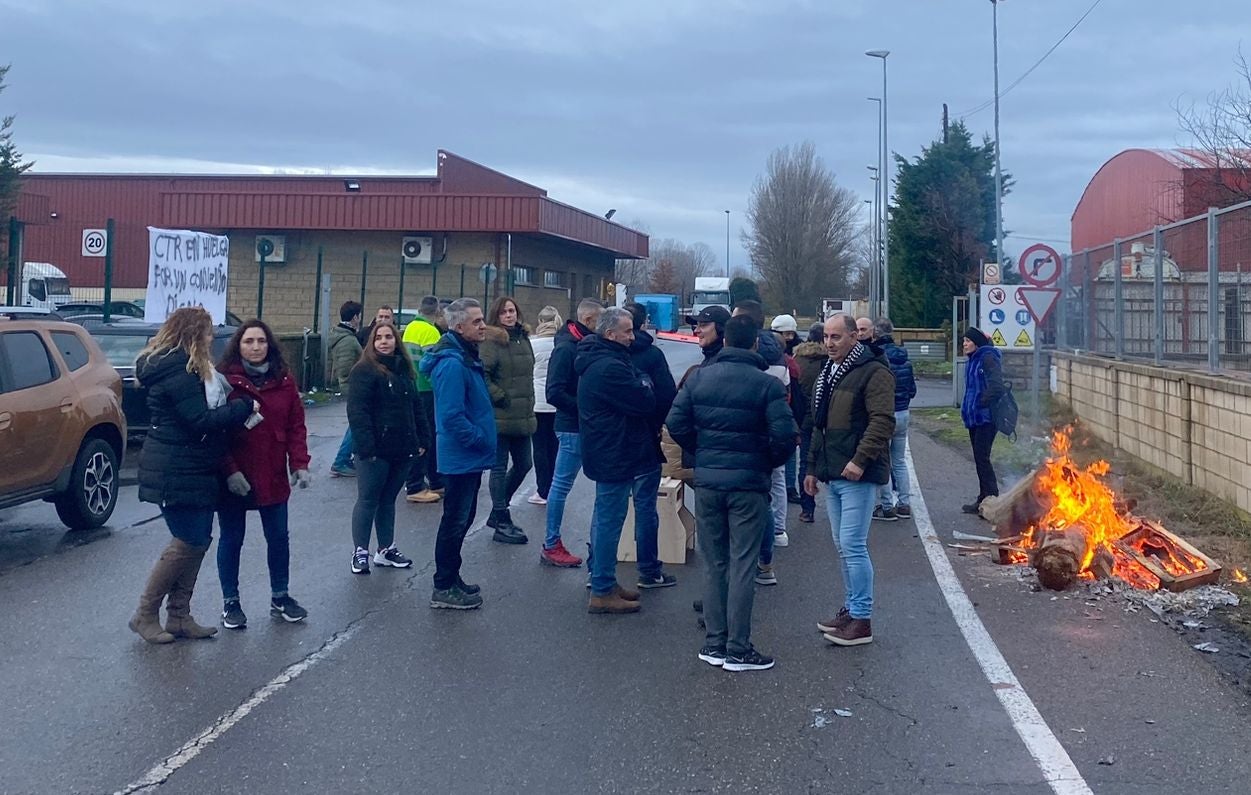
{"left": 0, "top": 307, "right": 126, "bottom": 530}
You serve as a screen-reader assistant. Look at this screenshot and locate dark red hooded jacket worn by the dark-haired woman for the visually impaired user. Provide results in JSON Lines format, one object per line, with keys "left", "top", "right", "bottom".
{"left": 223, "top": 362, "right": 309, "bottom": 507}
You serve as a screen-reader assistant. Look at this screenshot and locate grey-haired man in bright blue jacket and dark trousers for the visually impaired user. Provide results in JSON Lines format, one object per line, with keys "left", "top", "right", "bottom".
{"left": 419, "top": 298, "right": 495, "bottom": 610}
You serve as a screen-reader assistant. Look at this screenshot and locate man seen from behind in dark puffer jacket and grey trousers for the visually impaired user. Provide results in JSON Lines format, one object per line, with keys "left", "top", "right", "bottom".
{"left": 666, "top": 317, "right": 799, "bottom": 671}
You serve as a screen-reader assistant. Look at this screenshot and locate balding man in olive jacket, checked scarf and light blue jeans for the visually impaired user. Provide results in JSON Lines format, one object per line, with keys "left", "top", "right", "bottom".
{"left": 803, "top": 314, "right": 894, "bottom": 646}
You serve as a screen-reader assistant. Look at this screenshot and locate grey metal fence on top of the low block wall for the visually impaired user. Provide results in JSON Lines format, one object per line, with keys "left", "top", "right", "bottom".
{"left": 1056, "top": 202, "right": 1251, "bottom": 372}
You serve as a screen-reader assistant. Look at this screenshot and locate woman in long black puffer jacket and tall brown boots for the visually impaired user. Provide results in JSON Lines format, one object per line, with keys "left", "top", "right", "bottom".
{"left": 130, "top": 307, "right": 256, "bottom": 644}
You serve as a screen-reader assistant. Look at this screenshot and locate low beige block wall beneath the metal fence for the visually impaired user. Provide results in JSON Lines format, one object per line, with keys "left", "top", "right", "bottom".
{"left": 1055, "top": 352, "right": 1251, "bottom": 512}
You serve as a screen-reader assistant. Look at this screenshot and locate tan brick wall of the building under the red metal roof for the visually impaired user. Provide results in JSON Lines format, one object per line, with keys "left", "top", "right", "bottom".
{"left": 226, "top": 232, "right": 614, "bottom": 332}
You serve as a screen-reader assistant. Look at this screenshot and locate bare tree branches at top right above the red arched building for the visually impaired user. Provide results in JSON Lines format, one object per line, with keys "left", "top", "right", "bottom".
{"left": 1173, "top": 49, "right": 1251, "bottom": 210}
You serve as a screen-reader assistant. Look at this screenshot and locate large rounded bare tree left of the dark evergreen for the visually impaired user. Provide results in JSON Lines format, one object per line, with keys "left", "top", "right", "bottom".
{"left": 743, "top": 141, "right": 859, "bottom": 312}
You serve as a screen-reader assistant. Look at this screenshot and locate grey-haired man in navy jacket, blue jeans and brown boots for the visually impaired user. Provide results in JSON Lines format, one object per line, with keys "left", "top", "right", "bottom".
{"left": 574, "top": 307, "right": 664, "bottom": 613}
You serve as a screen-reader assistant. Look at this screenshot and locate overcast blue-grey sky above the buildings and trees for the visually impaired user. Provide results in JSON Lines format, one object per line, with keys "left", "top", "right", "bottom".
{"left": 0, "top": 0, "right": 1251, "bottom": 267}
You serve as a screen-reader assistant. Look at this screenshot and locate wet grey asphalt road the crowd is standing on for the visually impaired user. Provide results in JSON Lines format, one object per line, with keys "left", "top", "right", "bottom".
{"left": 0, "top": 343, "right": 1251, "bottom": 794}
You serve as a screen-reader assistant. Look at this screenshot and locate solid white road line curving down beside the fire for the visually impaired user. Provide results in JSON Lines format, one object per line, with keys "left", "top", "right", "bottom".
{"left": 904, "top": 443, "right": 1092, "bottom": 795}
